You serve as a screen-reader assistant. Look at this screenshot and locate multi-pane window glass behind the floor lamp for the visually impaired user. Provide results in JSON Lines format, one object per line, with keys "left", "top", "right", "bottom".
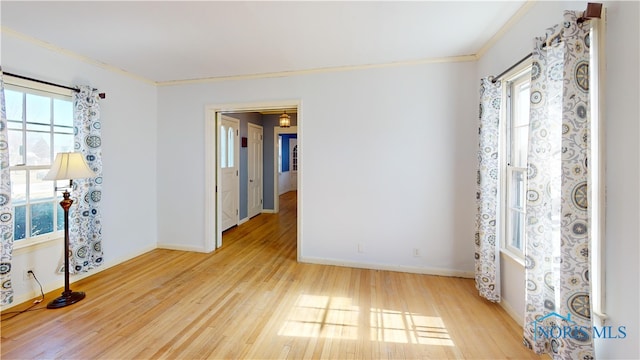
{"left": 5, "top": 81, "right": 74, "bottom": 243}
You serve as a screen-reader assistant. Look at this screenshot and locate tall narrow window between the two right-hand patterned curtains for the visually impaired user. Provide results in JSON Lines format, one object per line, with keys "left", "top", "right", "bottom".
{"left": 503, "top": 69, "right": 531, "bottom": 258}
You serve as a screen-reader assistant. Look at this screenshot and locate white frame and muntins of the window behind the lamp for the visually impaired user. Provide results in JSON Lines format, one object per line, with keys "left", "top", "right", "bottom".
{"left": 3, "top": 75, "right": 73, "bottom": 250}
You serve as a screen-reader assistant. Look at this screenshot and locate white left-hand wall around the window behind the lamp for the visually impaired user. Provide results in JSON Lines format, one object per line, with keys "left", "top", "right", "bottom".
{"left": 2, "top": 32, "right": 157, "bottom": 304}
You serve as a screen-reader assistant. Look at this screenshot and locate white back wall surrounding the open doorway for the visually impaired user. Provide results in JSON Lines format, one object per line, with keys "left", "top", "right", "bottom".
{"left": 158, "top": 62, "right": 477, "bottom": 275}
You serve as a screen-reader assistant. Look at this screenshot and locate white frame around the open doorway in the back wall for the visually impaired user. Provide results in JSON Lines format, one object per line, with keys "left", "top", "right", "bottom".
{"left": 204, "top": 100, "right": 304, "bottom": 260}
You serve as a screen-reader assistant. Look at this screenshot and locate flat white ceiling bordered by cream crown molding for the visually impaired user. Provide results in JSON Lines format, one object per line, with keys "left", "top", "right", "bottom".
{"left": 0, "top": 0, "right": 525, "bottom": 83}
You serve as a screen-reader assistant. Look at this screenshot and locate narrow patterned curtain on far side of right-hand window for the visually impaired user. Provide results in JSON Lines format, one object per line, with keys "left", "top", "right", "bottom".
{"left": 475, "top": 78, "right": 502, "bottom": 301}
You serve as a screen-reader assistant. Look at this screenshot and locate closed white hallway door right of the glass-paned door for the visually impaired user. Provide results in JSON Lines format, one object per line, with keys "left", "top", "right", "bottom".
{"left": 247, "top": 123, "right": 263, "bottom": 218}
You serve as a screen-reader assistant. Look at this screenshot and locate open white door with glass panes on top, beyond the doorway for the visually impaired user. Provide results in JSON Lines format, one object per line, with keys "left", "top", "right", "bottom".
{"left": 218, "top": 115, "right": 240, "bottom": 231}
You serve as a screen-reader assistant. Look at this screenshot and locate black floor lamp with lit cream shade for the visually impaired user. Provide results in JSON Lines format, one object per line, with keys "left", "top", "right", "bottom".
{"left": 43, "top": 152, "right": 96, "bottom": 309}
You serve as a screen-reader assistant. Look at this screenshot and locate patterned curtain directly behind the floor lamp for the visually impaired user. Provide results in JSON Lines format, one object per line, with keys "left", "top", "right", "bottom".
{"left": 69, "top": 86, "right": 103, "bottom": 274}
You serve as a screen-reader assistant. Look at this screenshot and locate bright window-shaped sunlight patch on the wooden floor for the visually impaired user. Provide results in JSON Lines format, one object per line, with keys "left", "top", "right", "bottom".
{"left": 278, "top": 294, "right": 454, "bottom": 346}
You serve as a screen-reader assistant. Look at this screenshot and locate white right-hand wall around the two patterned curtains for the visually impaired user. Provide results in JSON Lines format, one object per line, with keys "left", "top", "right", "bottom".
{"left": 477, "top": 1, "right": 640, "bottom": 359}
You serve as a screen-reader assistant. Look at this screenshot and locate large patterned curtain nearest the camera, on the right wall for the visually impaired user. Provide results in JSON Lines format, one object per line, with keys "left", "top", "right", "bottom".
{"left": 524, "top": 11, "right": 594, "bottom": 360}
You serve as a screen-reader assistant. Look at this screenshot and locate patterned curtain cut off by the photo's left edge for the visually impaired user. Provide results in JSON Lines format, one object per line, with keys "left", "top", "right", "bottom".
{"left": 0, "top": 68, "right": 13, "bottom": 305}
